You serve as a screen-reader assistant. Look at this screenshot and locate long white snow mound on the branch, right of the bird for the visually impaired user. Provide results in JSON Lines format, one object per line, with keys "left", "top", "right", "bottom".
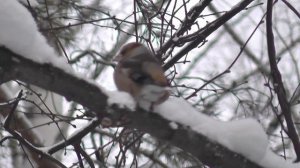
{"left": 154, "top": 97, "right": 300, "bottom": 168}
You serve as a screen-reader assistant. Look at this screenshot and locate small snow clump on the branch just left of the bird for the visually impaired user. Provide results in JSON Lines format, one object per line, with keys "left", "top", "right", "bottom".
{"left": 105, "top": 91, "right": 136, "bottom": 111}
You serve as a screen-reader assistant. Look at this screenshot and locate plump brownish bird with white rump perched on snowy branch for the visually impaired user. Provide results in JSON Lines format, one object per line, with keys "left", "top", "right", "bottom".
{"left": 114, "top": 42, "right": 169, "bottom": 110}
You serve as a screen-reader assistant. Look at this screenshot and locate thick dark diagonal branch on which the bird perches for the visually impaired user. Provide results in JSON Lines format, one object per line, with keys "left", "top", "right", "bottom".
{"left": 0, "top": 48, "right": 260, "bottom": 168}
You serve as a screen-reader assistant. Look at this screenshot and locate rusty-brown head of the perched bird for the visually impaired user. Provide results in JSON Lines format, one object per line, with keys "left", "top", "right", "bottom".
{"left": 113, "top": 42, "right": 150, "bottom": 62}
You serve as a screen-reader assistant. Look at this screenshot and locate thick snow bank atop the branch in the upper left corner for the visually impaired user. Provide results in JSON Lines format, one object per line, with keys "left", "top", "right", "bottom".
{"left": 0, "top": 0, "right": 72, "bottom": 73}
